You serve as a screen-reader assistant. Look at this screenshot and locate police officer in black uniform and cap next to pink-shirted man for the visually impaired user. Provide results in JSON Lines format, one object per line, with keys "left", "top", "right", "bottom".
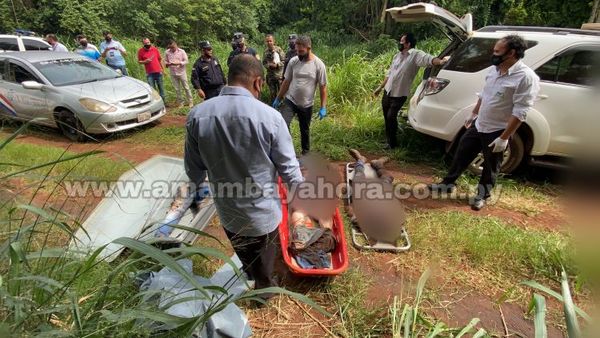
{"left": 192, "top": 41, "right": 225, "bottom": 100}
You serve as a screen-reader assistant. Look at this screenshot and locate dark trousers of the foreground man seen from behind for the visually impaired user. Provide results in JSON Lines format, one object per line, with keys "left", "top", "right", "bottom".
{"left": 225, "top": 229, "right": 279, "bottom": 289}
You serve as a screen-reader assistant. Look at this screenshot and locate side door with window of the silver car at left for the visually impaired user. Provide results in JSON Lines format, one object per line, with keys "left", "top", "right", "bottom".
{"left": 0, "top": 58, "right": 50, "bottom": 120}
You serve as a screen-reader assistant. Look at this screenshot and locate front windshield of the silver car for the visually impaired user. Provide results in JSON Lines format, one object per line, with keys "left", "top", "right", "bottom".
{"left": 34, "top": 59, "right": 119, "bottom": 87}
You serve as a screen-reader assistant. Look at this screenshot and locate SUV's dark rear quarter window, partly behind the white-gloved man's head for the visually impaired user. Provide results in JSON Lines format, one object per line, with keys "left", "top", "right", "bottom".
{"left": 444, "top": 38, "right": 537, "bottom": 73}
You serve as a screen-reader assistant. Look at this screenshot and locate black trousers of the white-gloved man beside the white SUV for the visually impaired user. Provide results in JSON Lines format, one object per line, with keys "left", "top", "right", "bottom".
{"left": 442, "top": 123, "right": 504, "bottom": 198}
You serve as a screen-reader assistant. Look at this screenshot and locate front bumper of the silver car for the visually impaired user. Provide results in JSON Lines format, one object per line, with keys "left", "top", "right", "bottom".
{"left": 78, "top": 100, "right": 167, "bottom": 134}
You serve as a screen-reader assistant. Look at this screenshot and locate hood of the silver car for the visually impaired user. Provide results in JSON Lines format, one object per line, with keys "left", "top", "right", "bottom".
{"left": 60, "top": 76, "right": 151, "bottom": 104}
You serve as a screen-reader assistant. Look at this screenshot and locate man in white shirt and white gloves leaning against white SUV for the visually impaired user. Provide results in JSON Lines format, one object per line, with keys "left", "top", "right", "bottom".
{"left": 429, "top": 35, "right": 540, "bottom": 210}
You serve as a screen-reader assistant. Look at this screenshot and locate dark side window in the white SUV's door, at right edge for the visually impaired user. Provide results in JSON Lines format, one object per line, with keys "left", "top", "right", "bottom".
{"left": 536, "top": 48, "right": 600, "bottom": 86}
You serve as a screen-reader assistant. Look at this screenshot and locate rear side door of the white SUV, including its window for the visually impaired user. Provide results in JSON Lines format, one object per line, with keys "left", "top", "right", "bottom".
{"left": 535, "top": 45, "right": 600, "bottom": 157}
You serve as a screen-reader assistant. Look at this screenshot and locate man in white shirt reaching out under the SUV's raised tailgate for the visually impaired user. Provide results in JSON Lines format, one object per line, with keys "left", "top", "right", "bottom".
{"left": 373, "top": 33, "right": 446, "bottom": 149}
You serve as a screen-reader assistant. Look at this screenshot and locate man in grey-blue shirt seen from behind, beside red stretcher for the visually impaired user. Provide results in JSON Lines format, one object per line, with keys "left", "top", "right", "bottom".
{"left": 184, "top": 55, "right": 303, "bottom": 298}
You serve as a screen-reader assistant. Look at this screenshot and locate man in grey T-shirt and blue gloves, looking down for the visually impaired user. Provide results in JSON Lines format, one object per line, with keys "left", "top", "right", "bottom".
{"left": 273, "top": 35, "right": 327, "bottom": 154}
